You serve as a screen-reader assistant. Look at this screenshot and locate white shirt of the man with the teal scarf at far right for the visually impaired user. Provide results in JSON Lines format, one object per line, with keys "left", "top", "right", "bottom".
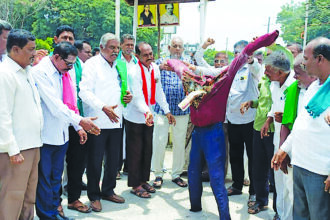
{"left": 281, "top": 80, "right": 330, "bottom": 175}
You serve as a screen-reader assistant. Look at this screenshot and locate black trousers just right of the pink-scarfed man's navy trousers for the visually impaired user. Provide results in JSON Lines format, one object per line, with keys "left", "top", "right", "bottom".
{"left": 66, "top": 126, "right": 91, "bottom": 203}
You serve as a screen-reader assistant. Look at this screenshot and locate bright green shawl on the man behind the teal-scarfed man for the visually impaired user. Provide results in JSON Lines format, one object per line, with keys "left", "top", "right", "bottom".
{"left": 282, "top": 80, "right": 300, "bottom": 130}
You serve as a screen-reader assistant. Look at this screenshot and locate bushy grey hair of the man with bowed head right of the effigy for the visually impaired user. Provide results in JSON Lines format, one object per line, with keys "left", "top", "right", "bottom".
{"left": 264, "top": 51, "right": 290, "bottom": 73}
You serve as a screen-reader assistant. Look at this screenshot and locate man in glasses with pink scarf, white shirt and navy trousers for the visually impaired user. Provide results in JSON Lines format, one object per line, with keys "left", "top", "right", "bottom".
{"left": 32, "top": 42, "right": 100, "bottom": 219}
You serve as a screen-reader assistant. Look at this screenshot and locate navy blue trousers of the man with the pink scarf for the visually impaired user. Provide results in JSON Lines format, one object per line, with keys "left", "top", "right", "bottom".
{"left": 36, "top": 142, "right": 68, "bottom": 220}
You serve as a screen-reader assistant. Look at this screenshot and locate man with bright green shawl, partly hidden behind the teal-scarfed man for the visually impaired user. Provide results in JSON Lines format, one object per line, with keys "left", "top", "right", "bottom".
{"left": 280, "top": 54, "right": 316, "bottom": 174}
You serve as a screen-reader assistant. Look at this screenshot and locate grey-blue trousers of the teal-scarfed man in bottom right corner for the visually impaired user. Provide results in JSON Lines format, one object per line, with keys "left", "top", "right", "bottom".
{"left": 293, "top": 166, "right": 330, "bottom": 220}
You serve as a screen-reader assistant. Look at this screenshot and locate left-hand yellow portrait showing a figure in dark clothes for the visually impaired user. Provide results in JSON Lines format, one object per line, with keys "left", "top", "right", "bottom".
{"left": 137, "top": 5, "right": 157, "bottom": 27}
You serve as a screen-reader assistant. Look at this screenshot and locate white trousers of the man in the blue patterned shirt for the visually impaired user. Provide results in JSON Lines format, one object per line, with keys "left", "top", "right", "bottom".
{"left": 151, "top": 114, "right": 189, "bottom": 179}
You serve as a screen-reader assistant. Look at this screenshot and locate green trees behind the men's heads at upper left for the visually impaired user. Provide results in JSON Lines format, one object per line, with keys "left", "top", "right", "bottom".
{"left": 0, "top": 0, "right": 157, "bottom": 50}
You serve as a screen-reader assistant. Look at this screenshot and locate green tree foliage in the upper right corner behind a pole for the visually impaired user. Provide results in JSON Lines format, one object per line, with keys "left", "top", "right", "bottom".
{"left": 277, "top": 0, "right": 330, "bottom": 43}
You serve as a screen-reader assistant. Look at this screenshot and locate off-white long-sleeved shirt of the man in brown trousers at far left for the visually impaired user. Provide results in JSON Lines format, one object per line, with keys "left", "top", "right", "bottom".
{"left": 0, "top": 57, "right": 43, "bottom": 156}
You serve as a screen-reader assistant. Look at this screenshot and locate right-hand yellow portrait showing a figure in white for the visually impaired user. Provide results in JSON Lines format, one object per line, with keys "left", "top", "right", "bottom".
{"left": 159, "top": 3, "right": 180, "bottom": 26}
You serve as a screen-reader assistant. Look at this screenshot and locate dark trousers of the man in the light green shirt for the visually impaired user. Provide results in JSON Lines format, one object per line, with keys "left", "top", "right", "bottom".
{"left": 253, "top": 130, "right": 276, "bottom": 210}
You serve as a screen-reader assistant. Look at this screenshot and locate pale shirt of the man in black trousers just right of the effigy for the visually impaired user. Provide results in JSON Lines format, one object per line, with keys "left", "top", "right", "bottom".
{"left": 226, "top": 59, "right": 261, "bottom": 124}
